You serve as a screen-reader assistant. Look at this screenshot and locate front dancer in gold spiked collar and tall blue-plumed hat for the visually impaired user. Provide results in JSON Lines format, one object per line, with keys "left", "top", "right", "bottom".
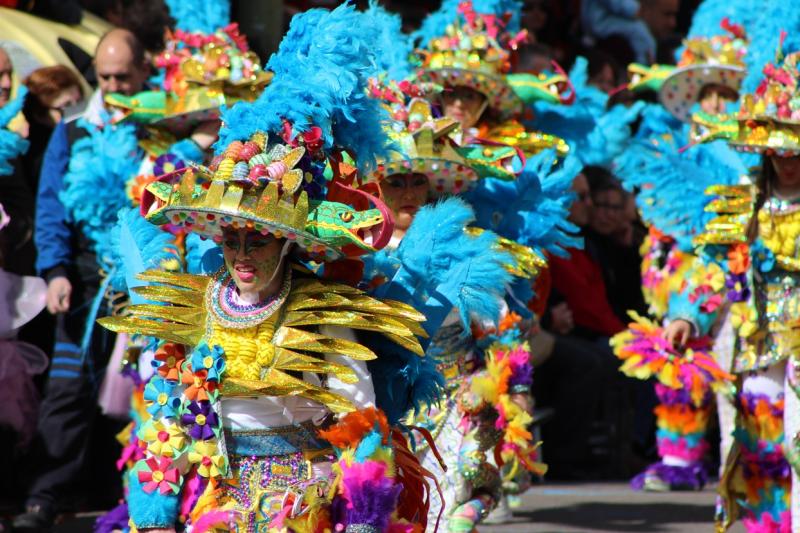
{"left": 97, "top": 5, "right": 446, "bottom": 531}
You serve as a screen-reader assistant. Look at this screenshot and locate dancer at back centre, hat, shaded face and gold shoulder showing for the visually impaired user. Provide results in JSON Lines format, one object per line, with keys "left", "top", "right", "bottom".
{"left": 414, "top": 0, "right": 575, "bottom": 159}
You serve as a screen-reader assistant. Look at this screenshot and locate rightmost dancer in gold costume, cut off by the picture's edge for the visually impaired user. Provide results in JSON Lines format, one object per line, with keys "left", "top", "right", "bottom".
{"left": 665, "top": 43, "right": 800, "bottom": 532}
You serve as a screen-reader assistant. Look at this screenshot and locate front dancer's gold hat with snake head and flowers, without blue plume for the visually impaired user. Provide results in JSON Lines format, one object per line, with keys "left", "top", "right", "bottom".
{"left": 141, "top": 129, "right": 392, "bottom": 260}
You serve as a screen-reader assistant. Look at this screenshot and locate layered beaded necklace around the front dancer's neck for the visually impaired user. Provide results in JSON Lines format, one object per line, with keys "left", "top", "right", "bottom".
{"left": 206, "top": 266, "right": 292, "bottom": 329}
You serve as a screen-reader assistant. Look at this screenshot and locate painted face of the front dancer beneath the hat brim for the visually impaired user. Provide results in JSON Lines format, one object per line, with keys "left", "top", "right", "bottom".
{"left": 222, "top": 229, "right": 284, "bottom": 298}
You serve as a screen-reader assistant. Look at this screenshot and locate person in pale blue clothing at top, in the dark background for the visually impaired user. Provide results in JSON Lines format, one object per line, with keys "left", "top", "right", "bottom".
{"left": 581, "top": 0, "right": 656, "bottom": 64}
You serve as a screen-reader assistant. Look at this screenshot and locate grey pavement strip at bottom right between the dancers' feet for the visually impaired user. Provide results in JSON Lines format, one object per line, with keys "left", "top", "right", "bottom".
{"left": 479, "top": 483, "right": 744, "bottom": 533}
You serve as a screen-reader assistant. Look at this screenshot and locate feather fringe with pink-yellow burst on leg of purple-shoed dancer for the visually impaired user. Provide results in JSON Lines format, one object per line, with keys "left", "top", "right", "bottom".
{"left": 611, "top": 312, "right": 734, "bottom": 490}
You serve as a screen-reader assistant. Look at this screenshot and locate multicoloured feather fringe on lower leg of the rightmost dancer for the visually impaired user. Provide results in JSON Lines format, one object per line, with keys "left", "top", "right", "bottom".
{"left": 734, "top": 392, "right": 792, "bottom": 533}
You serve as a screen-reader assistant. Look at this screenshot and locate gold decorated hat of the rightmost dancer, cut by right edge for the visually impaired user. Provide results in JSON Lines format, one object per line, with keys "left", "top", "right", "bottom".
{"left": 731, "top": 34, "right": 800, "bottom": 155}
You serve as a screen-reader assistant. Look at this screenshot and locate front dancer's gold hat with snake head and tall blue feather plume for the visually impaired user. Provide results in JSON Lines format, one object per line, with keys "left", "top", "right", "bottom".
{"left": 142, "top": 4, "right": 392, "bottom": 260}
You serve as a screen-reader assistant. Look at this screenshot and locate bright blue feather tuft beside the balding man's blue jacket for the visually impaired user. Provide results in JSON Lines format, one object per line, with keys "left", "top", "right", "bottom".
{"left": 59, "top": 119, "right": 142, "bottom": 264}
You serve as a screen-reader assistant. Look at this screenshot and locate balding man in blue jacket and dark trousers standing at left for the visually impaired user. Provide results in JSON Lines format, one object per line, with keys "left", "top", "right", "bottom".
{"left": 14, "top": 29, "right": 149, "bottom": 532}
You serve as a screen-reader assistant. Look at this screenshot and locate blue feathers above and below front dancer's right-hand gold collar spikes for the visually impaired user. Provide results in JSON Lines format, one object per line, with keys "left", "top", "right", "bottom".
{"left": 366, "top": 198, "right": 513, "bottom": 423}
